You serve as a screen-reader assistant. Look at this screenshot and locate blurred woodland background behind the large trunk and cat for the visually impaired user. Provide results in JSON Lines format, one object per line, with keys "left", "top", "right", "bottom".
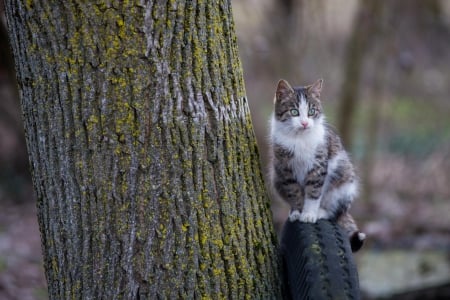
{"left": 0, "top": 0, "right": 450, "bottom": 300}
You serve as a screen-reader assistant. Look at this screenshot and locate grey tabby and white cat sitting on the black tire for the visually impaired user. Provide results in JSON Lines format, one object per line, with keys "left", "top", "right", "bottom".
{"left": 269, "top": 79, "right": 366, "bottom": 252}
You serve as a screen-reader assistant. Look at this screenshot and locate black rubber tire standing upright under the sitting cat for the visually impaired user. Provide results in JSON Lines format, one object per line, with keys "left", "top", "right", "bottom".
{"left": 281, "top": 220, "right": 360, "bottom": 300}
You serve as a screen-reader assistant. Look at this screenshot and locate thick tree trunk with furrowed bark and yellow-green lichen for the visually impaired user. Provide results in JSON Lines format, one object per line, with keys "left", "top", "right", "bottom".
{"left": 6, "top": 0, "right": 280, "bottom": 299}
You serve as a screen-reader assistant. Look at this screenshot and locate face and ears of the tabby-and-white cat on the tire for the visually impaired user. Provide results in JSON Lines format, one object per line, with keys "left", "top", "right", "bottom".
{"left": 275, "top": 79, "right": 323, "bottom": 135}
